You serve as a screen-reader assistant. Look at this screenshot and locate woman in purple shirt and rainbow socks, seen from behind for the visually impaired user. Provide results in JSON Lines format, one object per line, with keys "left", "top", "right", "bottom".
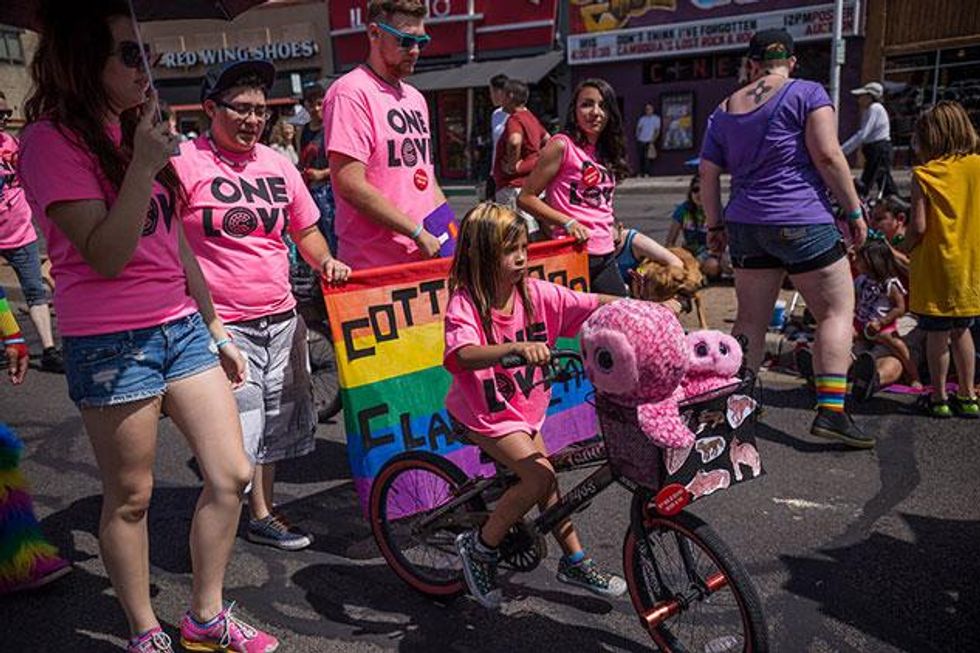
{"left": 701, "top": 29, "right": 874, "bottom": 448}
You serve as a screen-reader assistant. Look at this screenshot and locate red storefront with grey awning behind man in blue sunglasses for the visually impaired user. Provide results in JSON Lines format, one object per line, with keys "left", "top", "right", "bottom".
{"left": 329, "top": 0, "right": 567, "bottom": 183}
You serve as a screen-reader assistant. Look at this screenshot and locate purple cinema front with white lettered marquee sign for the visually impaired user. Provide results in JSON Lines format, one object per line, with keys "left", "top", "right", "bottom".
{"left": 567, "top": 0, "right": 864, "bottom": 175}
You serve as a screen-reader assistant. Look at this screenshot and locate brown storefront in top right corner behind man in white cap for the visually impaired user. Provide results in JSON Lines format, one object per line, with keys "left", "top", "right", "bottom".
{"left": 864, "top": 0, "right": 980, "bottom": 165}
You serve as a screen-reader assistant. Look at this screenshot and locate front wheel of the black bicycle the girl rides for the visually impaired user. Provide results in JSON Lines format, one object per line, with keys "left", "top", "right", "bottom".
{"left": 623, "top": 513, "right": 769, "bottom": 653}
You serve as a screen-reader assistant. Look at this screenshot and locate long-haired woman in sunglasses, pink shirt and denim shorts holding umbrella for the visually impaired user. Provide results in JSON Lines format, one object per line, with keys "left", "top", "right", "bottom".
{"left": 20, "top": 0, "right": 278, "bottom": 653}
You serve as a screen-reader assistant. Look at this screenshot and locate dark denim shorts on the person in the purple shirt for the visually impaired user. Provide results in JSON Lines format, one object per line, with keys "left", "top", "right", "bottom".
{"left": 725, "top": 222, "right": 847, "bottom": 274}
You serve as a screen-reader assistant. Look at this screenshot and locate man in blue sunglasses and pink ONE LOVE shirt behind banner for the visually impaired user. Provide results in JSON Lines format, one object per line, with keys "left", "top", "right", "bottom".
{"left": 323, "top": 0, "right": 451, "bottom": 270}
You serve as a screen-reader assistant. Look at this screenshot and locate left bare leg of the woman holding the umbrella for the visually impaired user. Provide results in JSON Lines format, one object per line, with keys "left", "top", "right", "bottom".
{"left": 81, "top": 398, "right": 160, "bottom": 635}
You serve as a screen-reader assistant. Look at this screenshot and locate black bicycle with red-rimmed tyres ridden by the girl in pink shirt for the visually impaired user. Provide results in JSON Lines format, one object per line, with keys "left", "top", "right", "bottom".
{"left": 369, "top": 350, "right": 768, "bottom": 653}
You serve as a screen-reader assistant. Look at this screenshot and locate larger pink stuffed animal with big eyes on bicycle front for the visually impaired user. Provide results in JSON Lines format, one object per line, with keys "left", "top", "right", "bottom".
{"left": 580, "top": 299, "right": 694, "bottom": 448}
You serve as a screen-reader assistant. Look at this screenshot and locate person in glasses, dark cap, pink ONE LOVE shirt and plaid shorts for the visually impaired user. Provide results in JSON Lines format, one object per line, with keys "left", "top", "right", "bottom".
{"left": 173, "top": 60, "right": 350, "bottom": 551}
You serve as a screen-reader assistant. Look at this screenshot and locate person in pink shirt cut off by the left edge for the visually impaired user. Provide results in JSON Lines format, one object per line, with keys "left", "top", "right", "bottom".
{"left": 0, "top": 92, "right": 65, "bottom": 373}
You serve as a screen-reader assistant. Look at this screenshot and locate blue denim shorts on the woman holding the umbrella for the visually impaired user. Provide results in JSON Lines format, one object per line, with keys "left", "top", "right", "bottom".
{"left": 62, "top": 313, "right": 218, "bottom": 408}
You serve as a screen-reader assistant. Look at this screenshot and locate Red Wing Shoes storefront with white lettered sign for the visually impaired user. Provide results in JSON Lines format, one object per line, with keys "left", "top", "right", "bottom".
{"left": 142, "top": 0, "right": 333, "bottom": 133}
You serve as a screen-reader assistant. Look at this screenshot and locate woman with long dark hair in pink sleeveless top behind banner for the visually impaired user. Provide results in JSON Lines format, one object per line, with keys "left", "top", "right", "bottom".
{"left": 517, "top": 79, "right": 629, "bottom": 297}
